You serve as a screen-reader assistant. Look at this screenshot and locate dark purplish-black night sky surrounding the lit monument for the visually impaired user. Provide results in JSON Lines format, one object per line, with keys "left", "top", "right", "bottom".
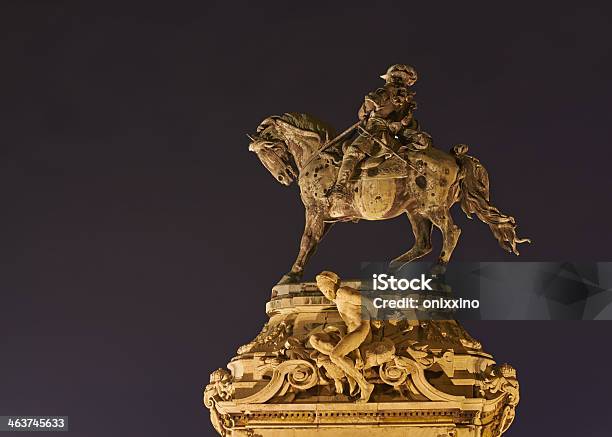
{"left": 0, "top": 0, "right": 612, "bottom": 437}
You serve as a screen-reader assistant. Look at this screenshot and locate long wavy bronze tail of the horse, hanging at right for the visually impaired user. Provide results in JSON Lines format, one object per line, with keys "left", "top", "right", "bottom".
{"left": 452, "top": 144, "right": 531, "bottom": 255}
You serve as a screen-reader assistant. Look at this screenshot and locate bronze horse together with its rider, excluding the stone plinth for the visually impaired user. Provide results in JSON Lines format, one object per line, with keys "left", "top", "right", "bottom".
{"left": 249, "top": 65, "right": 529, "bottom": 284}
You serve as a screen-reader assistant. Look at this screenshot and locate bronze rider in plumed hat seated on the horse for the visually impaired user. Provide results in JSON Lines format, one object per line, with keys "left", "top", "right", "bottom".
{"left": 330, "top": 64, "right": 418, "bottom": 204}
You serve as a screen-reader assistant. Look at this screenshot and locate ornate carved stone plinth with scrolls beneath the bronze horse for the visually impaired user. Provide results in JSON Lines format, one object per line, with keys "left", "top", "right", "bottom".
{"left": 204, "top": 281, "right": 519, "bottom": 437}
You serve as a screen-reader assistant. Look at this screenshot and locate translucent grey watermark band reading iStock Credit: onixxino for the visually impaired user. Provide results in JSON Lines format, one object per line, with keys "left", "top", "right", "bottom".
{"left": 359, "top": 261, "right": 612, "bottom": 320}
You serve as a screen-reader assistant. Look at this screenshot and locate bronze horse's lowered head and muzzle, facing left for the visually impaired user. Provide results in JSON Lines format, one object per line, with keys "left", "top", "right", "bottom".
{"left": 247, "top": 117, "right": 299, "bottom": 185}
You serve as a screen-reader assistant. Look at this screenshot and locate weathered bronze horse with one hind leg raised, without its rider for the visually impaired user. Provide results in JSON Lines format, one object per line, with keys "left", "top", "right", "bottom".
{"left": 249, "top": 113, "right": 530, "bottom": 283}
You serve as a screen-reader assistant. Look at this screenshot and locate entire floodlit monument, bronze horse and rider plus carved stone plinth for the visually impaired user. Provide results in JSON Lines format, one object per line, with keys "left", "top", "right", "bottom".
{"left": 203, "top": 65, "right": 528, "bottom": 437}
